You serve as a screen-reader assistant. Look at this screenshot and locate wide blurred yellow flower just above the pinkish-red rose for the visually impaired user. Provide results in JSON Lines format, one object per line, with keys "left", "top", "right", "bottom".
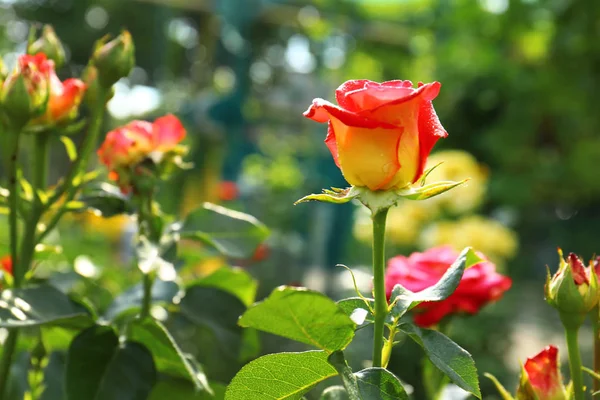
{"left": 420, "top": 215, "right": 518, "bottom": 262}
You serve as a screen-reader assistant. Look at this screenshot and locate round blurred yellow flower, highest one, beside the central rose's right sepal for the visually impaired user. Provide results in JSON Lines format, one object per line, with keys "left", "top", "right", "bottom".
{"left": 425, "top": 150, "right": 487, "bottom": 214}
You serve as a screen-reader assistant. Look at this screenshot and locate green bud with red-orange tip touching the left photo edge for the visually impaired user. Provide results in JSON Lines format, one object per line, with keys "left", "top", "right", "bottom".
{"left": 0, "top": 53, "right": 53, "bottom": 126}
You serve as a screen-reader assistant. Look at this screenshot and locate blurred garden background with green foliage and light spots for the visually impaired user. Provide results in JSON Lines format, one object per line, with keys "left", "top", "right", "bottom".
{"left": 0, "top": 0, "right": 600, "bottom": 397}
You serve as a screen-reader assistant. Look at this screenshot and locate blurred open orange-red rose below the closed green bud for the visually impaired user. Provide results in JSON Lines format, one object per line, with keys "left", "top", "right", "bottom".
{"left": 98, "top": 114, "right": 185, "bottom": 180}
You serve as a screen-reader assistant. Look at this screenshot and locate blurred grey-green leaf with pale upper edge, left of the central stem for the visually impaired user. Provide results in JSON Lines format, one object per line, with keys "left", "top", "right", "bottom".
{"left": 179, "top": 203, "right": 269, "bottom": 258}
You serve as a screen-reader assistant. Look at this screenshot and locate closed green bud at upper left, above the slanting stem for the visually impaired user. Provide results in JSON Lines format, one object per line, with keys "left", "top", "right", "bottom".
{"left": 91, "top": 31, "right": 135, "bottom": 88}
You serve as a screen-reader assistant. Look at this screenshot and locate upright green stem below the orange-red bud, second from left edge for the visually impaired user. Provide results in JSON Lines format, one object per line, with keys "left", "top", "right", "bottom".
{"left": 20, "top": 132, "right": 50, "bottom": 281}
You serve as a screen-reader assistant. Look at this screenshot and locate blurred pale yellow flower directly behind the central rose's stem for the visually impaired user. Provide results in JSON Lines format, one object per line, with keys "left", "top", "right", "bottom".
{"left": 353, "top": 200, "right": 435, "bottom": 245}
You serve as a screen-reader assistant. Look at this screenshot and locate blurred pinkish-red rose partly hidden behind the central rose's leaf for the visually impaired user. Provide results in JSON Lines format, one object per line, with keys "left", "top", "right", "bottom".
{"left": 386, "top": 246, "right": 512, "bottom": 327}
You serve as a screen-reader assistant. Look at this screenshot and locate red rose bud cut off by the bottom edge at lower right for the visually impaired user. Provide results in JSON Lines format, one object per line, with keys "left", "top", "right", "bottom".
{"left": 517, "top": 346, "right": 567, "bottom": 400}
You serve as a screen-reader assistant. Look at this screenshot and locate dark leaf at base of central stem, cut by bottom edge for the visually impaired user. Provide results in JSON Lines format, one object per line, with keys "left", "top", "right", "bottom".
{"left": 354, "top": 368, "right": 408, "bottom": 400}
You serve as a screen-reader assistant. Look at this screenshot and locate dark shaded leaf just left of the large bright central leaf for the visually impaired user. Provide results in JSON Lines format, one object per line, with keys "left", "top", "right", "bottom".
{"left": 179, "top": 286, "right": 246, "bottom": 358}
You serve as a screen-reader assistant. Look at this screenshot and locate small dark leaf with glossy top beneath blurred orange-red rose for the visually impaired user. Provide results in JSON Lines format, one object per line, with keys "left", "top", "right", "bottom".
{"left": 74, "top": 183, "right": 132, "bottom": 217}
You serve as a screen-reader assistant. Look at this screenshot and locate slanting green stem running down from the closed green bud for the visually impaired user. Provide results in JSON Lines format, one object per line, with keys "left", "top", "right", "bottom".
{"left": 36, "top": 87, "right": 111, "bottom": 243}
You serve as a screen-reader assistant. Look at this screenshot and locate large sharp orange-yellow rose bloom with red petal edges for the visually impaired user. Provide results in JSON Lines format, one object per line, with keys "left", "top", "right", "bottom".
{"left": 304, "top": 79, "right": 448, "bottom": 190}
